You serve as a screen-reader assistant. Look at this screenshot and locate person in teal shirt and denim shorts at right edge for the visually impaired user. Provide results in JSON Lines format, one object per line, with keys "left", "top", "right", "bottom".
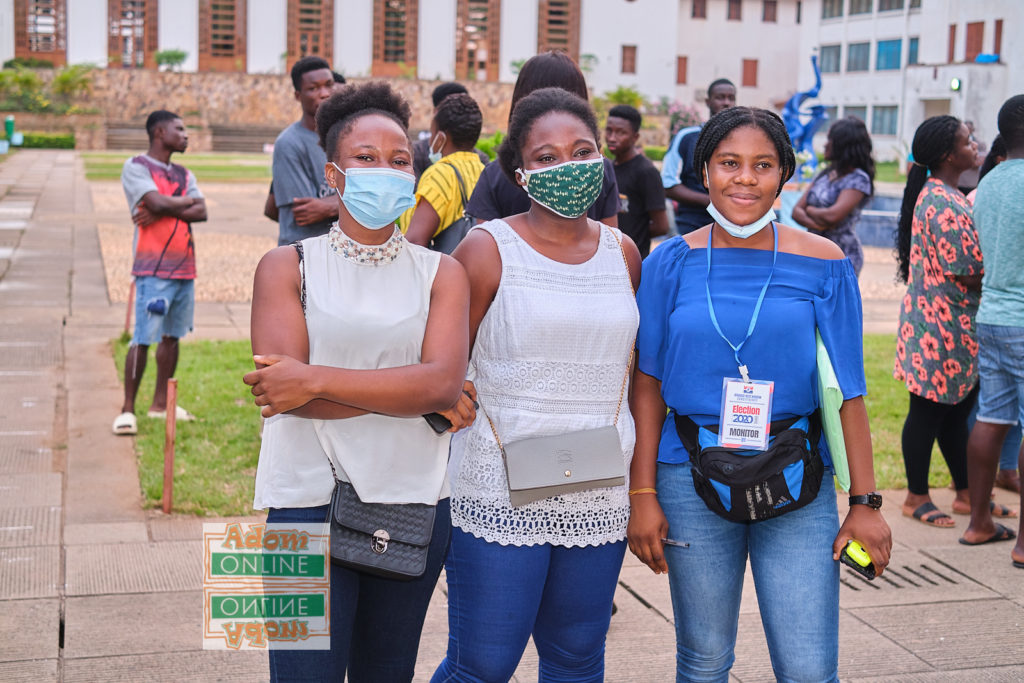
{"left": 961, "top": 95, "right": 1024, "bottom": 569}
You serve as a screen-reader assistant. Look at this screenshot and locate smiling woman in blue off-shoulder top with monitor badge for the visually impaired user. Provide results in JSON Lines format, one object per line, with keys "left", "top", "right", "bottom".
{"left": 629, "top": 108, "right": 892, "bottom": 681}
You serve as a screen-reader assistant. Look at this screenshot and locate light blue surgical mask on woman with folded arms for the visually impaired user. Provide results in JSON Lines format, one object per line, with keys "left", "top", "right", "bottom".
{"left": 331, "top": 162, "right": 416, "bottom": 230}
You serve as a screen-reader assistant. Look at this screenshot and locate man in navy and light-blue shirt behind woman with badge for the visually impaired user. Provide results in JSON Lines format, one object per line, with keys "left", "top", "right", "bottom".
{"left": 662, "top": 78, "right": 736, "bottom": 234}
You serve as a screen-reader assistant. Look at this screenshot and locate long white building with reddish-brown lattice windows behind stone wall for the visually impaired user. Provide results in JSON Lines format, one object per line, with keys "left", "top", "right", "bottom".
{"left": 0, "top": 0, "right": 807, "bottom": 105}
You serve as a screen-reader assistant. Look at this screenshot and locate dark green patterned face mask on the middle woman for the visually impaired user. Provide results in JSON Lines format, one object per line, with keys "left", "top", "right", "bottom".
{"left": 515, "top": 157, "right": 604, "bottom": 218}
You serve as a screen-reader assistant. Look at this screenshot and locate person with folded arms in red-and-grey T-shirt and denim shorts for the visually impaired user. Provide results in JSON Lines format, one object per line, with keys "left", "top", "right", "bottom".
{"left": 113, "top": 110, "right": 206, "bottom": 434}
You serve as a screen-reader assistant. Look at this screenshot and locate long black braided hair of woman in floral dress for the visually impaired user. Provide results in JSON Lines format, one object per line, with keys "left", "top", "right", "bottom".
{"left": 895, "top": 115, "right": 963, "bottom": 283}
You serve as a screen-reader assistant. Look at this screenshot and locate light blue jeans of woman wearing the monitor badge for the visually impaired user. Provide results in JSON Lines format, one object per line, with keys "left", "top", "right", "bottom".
{"left": 657, "top": 463, "right": 839, "bottom": 683}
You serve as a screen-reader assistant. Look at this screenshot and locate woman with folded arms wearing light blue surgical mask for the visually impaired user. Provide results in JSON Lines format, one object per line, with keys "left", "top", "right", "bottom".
{"left": 245, "top": 83, "right": 469, "bottom": 683}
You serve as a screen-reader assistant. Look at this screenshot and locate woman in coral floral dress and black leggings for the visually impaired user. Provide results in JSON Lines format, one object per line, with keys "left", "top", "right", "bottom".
{"left": 893, "top": 116, "right": 982, "bottom": 527}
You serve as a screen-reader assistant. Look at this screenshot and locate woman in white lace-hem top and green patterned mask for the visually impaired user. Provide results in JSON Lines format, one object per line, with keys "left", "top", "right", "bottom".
{"left": 433, "top": 88, "right": 640, "bottom": 682}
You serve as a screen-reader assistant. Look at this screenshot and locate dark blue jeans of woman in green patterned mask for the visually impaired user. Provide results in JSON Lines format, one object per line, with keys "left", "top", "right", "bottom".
{"left": 431, "top": 528, "right": 626, "bottom": 683}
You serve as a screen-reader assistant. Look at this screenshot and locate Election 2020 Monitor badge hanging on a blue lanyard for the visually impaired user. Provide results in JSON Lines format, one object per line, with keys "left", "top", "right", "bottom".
{"left": 718, "top": 377, "right": 775, "bottom": 451}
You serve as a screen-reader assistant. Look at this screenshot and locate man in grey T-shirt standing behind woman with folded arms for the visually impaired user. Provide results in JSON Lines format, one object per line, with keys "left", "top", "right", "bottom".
{"left": 273, "top": 56, "right": 338, "bottom": 246}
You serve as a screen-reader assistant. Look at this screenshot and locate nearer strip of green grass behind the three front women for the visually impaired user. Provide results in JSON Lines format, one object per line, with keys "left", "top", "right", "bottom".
{"left": 115, "top": 335, "right": 949, "bottom": 516}
